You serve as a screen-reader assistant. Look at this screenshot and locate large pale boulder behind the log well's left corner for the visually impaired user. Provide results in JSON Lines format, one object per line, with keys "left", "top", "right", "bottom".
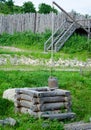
{"left": 3, "top": 88, "right": 16, "bottom": 102}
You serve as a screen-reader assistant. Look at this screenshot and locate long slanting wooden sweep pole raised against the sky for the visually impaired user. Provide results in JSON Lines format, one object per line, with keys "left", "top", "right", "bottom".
{"left": 53, "top": 1, "right": 91, "bottom": 34}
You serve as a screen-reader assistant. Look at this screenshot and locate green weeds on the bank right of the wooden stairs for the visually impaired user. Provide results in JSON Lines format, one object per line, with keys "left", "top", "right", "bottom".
{"left": 62, "top": 33, "right": 91, "bottom": 53}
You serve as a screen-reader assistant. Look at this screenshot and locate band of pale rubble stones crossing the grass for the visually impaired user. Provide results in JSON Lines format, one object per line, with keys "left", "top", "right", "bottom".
{"left": 0, "top": 54, "right": 91, "bottom": 67}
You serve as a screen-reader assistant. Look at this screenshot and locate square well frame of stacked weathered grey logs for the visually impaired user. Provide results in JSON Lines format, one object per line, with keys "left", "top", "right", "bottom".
{"left": 15, "top": 87, "right": 71, "bottom": 117}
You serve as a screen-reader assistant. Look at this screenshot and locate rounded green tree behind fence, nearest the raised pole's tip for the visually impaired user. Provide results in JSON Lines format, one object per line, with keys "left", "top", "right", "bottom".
{"left": 38, "top": 3, "right": 58, "bottom": 14}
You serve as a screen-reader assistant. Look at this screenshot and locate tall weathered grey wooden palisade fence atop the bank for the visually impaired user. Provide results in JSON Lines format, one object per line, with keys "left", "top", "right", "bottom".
{"left": 0, "top": 12, "right": 91, "bottom": 34}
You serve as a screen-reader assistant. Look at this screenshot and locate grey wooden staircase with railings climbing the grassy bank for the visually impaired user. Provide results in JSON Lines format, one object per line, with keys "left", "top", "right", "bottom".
{"left": 44, "top": 21, "right": 78, "bottom": 52}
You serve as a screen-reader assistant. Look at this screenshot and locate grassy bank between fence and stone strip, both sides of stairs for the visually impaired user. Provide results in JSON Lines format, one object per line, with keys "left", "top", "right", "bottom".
{"left": 0, "top": 30, "right": 91, "bottom": 60}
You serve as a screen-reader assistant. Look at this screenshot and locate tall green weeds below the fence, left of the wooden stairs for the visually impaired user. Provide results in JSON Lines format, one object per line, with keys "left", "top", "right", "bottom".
{"left": 0, "top": 30, "right": 51, "bottom": 50}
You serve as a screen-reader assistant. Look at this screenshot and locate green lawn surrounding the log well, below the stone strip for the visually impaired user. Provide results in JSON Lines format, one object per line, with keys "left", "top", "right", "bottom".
{"left": 0, "top": 70, "right": 91, "bottom": 130}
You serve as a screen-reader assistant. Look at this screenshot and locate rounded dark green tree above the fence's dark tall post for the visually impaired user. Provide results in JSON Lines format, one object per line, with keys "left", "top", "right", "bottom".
{"left": 23, "top": 1, "right": 36, "bottom": 13}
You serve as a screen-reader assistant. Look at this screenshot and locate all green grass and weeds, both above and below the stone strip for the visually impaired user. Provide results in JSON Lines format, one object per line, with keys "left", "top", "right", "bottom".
{"left": 0, "top": 31, "right": 91, "bottom": 130}
